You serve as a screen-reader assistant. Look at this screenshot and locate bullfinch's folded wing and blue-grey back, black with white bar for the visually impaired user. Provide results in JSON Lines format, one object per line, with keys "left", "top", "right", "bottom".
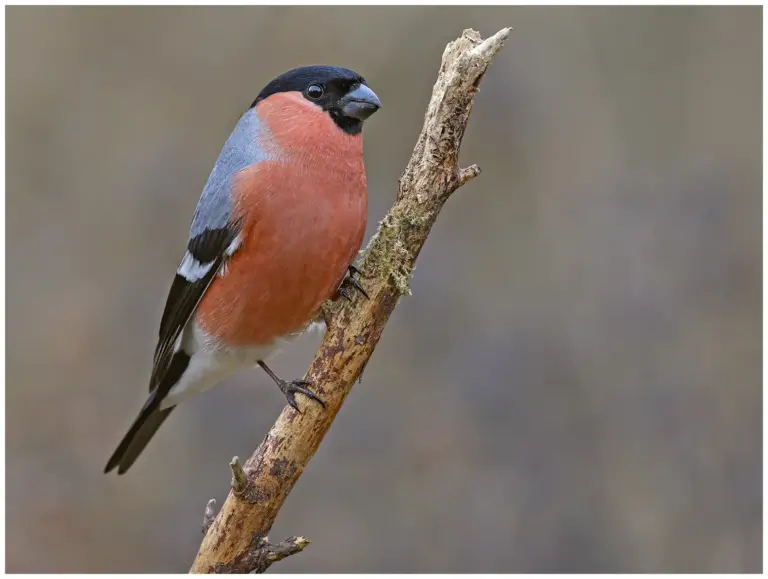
{"left": 149, "top": 109, "right": 270, "bottom": 394}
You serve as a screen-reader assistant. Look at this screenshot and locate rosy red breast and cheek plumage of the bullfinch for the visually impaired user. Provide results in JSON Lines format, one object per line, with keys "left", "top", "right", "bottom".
{"left": 198, "top": 92, "right": 368, "bottom": 346}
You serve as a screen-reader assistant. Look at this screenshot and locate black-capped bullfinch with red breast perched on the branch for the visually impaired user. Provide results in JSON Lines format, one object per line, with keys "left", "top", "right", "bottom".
{"left": 104, "top": 65, "right": 381, "bottom": 474}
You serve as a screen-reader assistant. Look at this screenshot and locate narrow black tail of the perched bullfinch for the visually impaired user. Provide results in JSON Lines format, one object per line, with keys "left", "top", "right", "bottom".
{"left": 104, "top": 351, "right": 189, "bottom": 474}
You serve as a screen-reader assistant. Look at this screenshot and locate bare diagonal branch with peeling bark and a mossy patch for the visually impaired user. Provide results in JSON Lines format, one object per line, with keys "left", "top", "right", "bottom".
{"left": 191, "top": 28, "right": 511, "bottom": 573}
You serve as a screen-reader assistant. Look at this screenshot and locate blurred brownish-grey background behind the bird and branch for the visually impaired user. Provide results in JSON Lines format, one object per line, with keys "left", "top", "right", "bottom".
{"left": 6, "top": 7, "right": 762, "bottom": 572}
